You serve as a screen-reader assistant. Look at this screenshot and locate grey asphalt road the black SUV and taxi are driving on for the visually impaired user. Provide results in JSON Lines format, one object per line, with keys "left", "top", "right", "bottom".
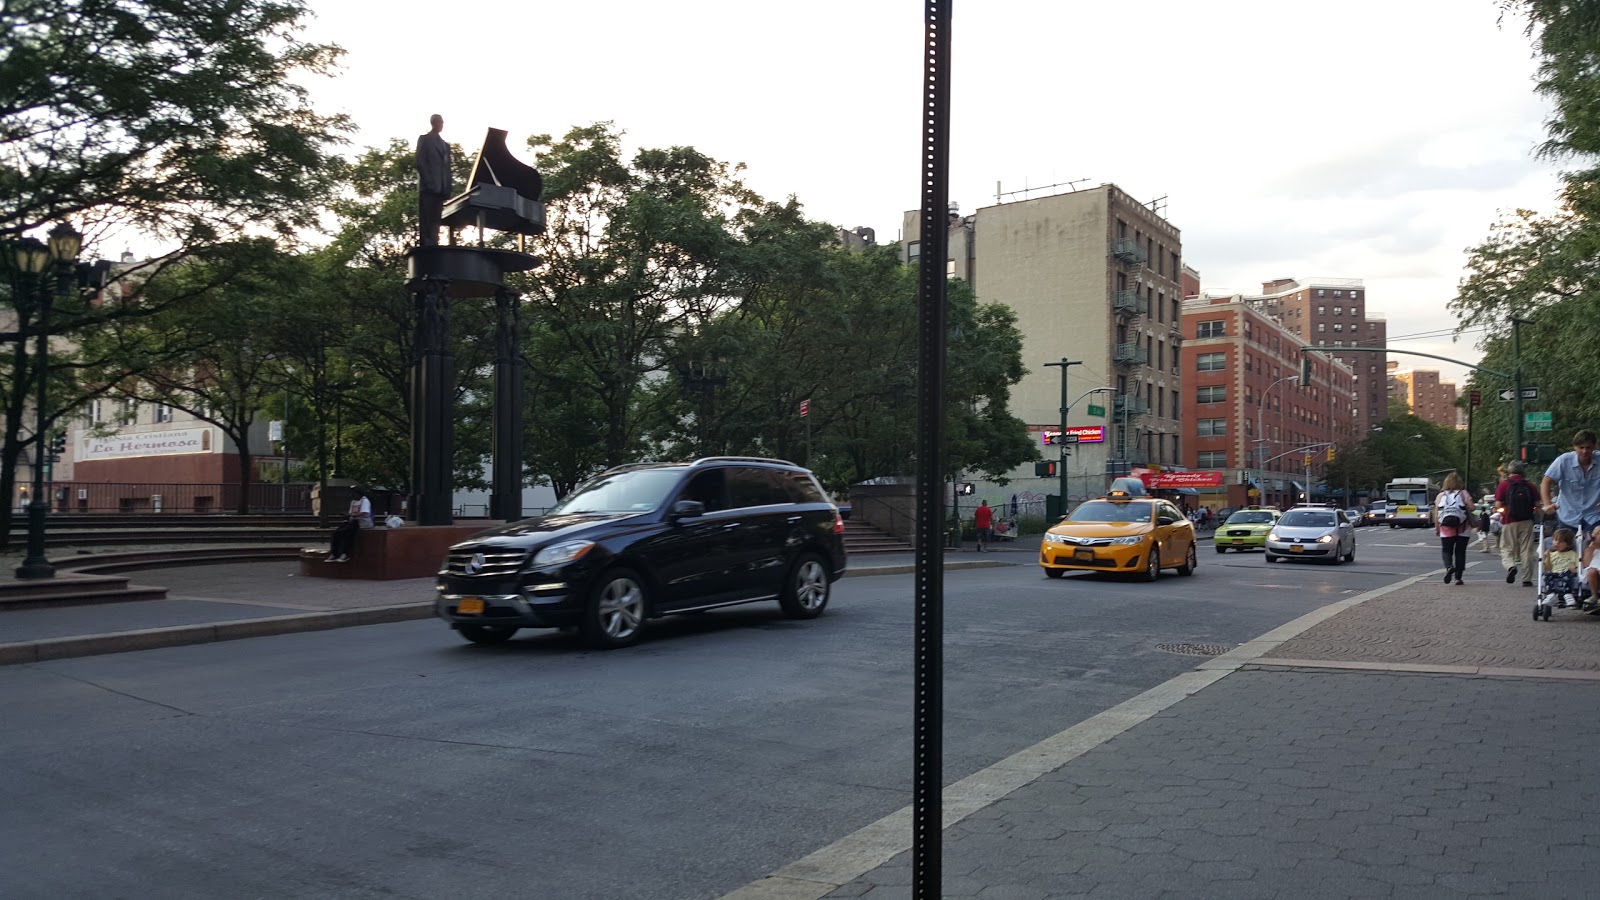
{"left": 0, "top": 530, "right": 1446, "bottom": 900}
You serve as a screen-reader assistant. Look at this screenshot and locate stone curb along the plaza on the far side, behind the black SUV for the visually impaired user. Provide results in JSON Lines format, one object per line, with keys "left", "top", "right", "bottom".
{"left": 0, "top": 557, "right": 1032, "bottom": 666}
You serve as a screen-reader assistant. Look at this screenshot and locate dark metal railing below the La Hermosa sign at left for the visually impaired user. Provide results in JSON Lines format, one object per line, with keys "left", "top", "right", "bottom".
{"left": 24, "top": 482, "right": 314, "bottom": 516}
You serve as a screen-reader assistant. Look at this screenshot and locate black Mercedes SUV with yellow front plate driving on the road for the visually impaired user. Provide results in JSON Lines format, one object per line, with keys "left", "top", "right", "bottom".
{"left": 434, "top": 456, "right": 845, "bottom": 647}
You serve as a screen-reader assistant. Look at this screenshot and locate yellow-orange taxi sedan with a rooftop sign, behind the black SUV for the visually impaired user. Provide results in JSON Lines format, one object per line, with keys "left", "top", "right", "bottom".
{"left": 1038, "top": 479, "right": 1198, "bottom": 581}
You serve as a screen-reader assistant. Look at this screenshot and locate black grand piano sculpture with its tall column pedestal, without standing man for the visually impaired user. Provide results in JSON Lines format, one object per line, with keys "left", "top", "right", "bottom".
{"left": 406, "top": 128, "right": 544, "bottom": 525}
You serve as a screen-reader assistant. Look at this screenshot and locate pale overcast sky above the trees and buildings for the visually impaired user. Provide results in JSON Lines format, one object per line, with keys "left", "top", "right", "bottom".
{"left": 294, "top": 0, "right": 1557, "bottom": 389}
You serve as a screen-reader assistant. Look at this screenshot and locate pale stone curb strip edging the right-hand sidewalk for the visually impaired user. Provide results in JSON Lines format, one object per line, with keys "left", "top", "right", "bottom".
{"left": 722, "top": 569, "right": 1443, "bottom": 900}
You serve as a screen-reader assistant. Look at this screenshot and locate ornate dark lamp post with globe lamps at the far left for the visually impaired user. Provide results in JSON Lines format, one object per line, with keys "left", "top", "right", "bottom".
{"left": 14, "top": 223, "right": 83, "bottom": 578}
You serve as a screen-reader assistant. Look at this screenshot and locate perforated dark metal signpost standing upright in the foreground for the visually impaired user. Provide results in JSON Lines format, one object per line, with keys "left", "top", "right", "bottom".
{"left": 910, "top": 0, "right": 952, "bottom": 900}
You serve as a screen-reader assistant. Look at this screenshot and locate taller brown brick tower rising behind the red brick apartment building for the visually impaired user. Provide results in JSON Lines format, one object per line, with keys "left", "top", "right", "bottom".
{"left": 1254, "top": 277, "right": 1389, "bottom": 428}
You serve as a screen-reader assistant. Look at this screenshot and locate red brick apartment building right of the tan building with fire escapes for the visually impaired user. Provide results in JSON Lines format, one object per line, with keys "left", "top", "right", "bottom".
{"left": 1182, "top": 295, "right": 1366, "bottom": 508}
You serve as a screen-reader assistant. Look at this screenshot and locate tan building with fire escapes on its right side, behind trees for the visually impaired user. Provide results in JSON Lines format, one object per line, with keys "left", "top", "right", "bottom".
{"left": 902, "top": 184, "right": 1182, "bottom": 495}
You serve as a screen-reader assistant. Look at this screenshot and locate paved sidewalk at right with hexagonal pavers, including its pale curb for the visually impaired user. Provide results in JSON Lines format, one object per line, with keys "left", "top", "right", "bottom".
{"left": 726, "top": 554, "right": 1600, "bottom": 900}
